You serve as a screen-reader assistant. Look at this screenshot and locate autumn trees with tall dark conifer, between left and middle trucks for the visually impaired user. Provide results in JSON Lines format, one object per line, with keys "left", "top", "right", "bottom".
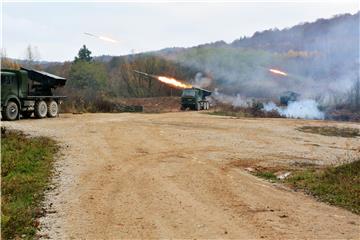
{"left": 44, "top": 45, "right": 197, "bottom": 111}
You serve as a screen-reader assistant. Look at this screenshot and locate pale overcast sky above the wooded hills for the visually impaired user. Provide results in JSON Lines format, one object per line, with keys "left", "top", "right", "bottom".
{"left": 1, "top": 0, "right": 359, "bottom": 61}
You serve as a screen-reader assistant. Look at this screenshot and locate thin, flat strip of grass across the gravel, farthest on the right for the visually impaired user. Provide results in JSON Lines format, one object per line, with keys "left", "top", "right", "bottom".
{"left": 297, "top": 126, "right": 360, "bottom": 138}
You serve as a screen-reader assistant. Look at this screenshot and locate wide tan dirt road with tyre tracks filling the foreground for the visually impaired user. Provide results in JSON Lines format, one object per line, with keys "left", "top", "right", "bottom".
{"left": 3, "top": 112, "right": 360, "bottom": 239}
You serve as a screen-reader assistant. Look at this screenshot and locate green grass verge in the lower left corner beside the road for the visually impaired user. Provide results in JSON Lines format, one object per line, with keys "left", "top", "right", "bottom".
{"left": 1, "top": 131, "right": 58, "bottom": 239}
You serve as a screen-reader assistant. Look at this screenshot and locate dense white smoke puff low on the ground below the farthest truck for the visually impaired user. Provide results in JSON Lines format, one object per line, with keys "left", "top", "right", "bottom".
{"left": 264, "top": 99, "right": 325, "bottom": 119}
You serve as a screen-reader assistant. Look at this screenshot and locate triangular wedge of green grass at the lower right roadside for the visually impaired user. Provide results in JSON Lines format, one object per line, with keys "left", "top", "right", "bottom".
{"left": 285, "top": 159, "right": 360, "bottom": 214}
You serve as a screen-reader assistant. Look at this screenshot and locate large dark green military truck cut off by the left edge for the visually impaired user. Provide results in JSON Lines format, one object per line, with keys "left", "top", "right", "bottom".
{"left": 1, "top": 67, "right": 66, "bottom": 121}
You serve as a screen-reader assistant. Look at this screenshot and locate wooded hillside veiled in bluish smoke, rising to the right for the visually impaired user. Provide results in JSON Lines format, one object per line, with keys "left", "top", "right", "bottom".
{"left": 155, "top": 13, "right": 359, "bottom": 97}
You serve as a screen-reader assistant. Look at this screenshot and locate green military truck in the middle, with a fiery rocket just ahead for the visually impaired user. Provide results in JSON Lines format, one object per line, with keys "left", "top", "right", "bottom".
{"left": 180, "top": 87, "right": 211, "bottom": 111}
